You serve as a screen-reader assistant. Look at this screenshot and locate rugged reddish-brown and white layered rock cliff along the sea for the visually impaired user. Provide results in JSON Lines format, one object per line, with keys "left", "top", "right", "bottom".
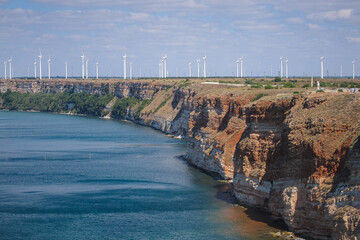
{"left": 0, "top": 80, "right": 360, "bottom": 239}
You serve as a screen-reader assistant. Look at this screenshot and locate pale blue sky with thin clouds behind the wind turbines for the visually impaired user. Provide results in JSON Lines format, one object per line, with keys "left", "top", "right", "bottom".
{"left": 0, "top": 0, "right": 360, "bottom": 78}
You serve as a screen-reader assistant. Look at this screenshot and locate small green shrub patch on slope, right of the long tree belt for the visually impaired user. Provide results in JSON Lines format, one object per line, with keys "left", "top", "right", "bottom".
{"left": 111, "top": 97, "right": 151, "bottom": 118}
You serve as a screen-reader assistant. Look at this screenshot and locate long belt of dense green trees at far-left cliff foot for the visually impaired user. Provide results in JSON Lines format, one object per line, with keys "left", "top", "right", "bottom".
{"left": 1, "top": 90, "right": 114, "bottom": 116}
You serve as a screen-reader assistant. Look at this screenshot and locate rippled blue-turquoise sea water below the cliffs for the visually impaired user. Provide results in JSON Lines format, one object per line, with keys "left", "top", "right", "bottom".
{"left": 0, "top": 111, "right": 278, "bottom": 239}
